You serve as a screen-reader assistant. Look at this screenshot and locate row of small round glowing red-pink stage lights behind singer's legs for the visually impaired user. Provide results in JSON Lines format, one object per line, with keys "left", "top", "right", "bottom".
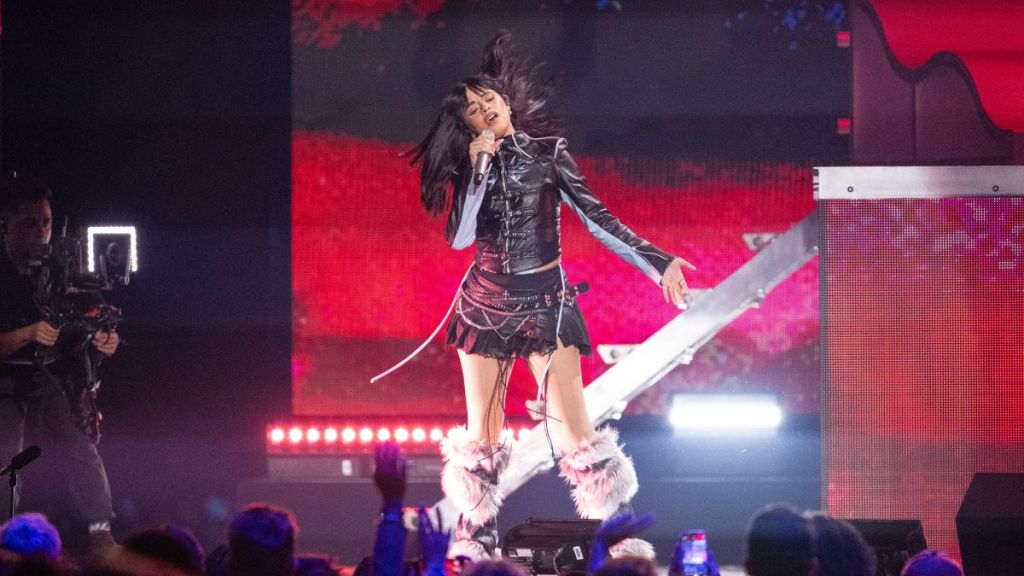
{"left": 267, "top": 424, "right": 530, "bottom": 452}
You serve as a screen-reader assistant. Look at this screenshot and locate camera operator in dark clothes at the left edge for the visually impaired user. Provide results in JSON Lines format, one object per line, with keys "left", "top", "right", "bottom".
{"left": 0, "top": 176, "right": 119, "bottom": 549}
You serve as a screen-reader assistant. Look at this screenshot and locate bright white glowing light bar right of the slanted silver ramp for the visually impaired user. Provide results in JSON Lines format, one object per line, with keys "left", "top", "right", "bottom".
{"left": 669, "top": 394, "right": 782, "bottom": 431}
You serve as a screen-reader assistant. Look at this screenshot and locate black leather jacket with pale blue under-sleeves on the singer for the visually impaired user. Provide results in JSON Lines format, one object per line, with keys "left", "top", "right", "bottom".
{"left": 444, "top": 132, "right": 675, "bottom": 283}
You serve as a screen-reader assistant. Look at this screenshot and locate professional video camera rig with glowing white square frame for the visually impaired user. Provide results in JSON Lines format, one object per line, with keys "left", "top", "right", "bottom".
{"left": 34, "top": 220, "right": 138, "bottom": 442}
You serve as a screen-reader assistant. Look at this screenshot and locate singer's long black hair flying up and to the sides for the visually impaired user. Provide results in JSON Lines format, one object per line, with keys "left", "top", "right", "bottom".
{"left": 402, "top": 30, "right": 560, "bottom": 214}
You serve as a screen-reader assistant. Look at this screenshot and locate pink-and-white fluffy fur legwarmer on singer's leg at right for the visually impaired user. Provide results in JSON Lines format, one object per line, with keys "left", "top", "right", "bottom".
{"left": 560, "top": 427, "right": 639, "bottom": 520}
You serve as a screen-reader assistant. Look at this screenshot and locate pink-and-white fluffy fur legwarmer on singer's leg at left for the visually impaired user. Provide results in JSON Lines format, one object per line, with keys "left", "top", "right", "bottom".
{"left": 441, "top": 426, "right": 509, "bottom": 526}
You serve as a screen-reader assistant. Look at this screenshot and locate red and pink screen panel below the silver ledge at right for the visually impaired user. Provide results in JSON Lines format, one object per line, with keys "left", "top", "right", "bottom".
{"left": 821, "top": 198, "right": 1024, "bottom": 552}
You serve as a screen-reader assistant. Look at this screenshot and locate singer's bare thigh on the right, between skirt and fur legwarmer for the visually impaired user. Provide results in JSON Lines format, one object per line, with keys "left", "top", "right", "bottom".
{"left": 528, "top": 338, "right": 594, "bottom": 449}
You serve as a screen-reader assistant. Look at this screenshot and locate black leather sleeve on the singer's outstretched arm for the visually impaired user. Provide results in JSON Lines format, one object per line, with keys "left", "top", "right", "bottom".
{"left": 554, "top": 140, "right": 676, "bottom": 284}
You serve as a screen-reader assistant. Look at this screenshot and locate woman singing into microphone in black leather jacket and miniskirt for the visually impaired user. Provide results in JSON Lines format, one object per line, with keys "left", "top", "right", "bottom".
{"left": 410, "top": 32, "right": 693, "bottom": 559}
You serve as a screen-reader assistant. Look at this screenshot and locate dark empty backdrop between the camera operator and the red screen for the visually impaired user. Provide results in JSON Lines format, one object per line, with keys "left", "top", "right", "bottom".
{"left": 2, "top": 1, "right": 291, "bottom": 541}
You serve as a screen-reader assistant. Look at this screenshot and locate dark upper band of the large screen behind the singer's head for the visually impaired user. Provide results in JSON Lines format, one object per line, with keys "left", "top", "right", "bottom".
{"left": 293, "top": 0, "right": 850, "bottom": 163}
